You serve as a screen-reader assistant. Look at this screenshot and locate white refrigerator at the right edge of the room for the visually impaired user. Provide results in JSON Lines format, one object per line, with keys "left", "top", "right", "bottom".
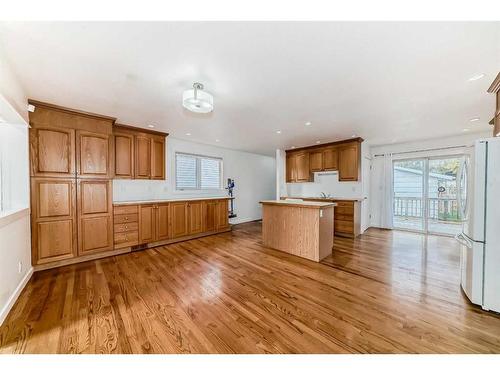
{"left": 455, "top": 138, "right": 500, "bottom": 312}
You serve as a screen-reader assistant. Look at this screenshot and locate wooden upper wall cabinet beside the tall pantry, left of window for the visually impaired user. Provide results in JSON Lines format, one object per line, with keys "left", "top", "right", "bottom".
{"left": 114, "top": 125, "right": 168, "bottom": 180}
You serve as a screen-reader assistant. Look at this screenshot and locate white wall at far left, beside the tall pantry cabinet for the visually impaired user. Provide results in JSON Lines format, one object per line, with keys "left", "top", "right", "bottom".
{"left": 0, "top": 42, "right": 33, "bottom": 324}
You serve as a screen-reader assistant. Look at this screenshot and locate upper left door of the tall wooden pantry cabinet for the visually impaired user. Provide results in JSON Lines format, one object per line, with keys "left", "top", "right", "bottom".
{"left": 29, "top": 127, "right": 75, "bottom": 177}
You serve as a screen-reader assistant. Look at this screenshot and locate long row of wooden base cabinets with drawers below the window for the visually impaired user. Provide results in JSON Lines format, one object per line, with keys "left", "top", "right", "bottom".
{"left": 114, "top": 199, "right": 230, "bottom": 249}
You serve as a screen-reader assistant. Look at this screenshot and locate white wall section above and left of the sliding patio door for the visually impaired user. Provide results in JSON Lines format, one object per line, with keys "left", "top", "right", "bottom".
{"left": 370, "top": 132, "right": 491, "bottom": 227}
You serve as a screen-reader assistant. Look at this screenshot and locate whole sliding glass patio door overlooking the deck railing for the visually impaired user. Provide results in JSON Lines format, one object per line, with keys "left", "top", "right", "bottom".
{"left": 393, "top": 155, "right": 464, "bottom": 235}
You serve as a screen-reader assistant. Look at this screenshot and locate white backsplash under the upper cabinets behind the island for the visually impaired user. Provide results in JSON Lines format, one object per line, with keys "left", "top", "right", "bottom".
{"left": 286, "top": 173, "right": 363, "bottom": 198}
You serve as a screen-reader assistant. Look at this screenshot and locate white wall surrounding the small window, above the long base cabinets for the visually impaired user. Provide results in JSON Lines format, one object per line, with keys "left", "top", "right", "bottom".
{"left": 113, "top": 137, "right": 276, "bottom": 224}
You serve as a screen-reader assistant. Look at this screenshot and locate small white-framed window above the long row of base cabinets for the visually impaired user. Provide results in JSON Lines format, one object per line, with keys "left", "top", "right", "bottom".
{"left": 175, "top": 153, "right": 222, "bottom": 190}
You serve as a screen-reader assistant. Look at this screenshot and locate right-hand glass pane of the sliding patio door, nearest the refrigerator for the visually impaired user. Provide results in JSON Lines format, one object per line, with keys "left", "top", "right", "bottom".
{"left": 428, "top": 157, "right": 466, "bottom": 235}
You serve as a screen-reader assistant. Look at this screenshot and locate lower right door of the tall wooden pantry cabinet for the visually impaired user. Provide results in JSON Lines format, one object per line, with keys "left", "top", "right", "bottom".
{"left": 77, "top": 179, "right": 113, "bottom": 255}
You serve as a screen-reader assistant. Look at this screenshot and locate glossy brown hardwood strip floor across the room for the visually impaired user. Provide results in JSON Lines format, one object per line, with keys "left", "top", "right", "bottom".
{"left": 0, "top": 223, "right": 500, "bottom": 353}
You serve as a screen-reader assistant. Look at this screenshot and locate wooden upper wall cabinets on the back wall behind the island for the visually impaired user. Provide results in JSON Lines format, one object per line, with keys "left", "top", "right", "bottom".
{"left": 286, "top": 138, "right": 363, "bottom": 182}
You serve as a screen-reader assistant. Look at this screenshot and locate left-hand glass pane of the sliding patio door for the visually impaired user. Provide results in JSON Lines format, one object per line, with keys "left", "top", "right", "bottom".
{"left": 393, "top": 159, "right": 424, "bottom": 230}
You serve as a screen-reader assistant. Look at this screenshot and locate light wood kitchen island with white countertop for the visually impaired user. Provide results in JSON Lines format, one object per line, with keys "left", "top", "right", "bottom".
{"left": 260, "top": 200, "right": 336, "bottom": 262}
